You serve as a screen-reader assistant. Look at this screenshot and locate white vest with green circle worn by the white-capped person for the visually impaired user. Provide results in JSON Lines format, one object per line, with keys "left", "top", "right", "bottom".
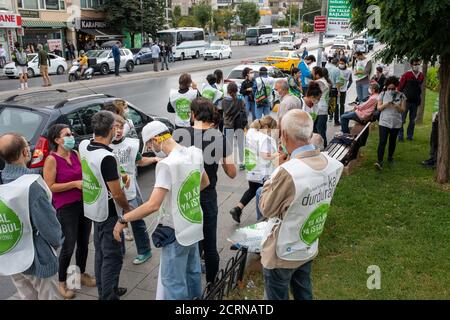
{"left": 156, "top": 146, "right": 203, "bottom": 246}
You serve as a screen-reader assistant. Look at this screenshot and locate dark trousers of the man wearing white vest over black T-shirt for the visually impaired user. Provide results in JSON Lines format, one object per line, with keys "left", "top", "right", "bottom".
{"left": 94, "top": 216, "right": 123, "bottom": 300}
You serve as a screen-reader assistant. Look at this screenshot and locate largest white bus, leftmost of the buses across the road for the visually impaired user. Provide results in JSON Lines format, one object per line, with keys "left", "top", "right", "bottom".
{"left": 158, "top": 27, "right": 206, "bottom": 60}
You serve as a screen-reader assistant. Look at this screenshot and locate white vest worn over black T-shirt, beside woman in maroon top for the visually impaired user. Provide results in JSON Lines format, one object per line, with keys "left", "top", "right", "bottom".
{"left": 79, "top": 140, "right": 122, "bottom": 222}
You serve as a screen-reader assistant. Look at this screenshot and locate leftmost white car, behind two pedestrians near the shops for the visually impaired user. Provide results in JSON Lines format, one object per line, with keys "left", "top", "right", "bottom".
{"left": 4, "top": 53, "right": 67, "bottom": 79}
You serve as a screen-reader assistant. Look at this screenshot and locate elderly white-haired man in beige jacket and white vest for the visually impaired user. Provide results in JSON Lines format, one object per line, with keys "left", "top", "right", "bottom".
{"left": 259, "top": 110, "right": 343, "bottom": 300}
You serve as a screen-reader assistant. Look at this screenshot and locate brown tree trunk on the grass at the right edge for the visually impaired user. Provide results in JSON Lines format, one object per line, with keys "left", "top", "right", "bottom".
{"left": 436, "top": 54, "right": 450, "bottom": 183}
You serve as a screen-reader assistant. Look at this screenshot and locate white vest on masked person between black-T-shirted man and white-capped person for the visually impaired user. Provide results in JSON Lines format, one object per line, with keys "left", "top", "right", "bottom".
{"left": 109, "top": 138, "right": 139, "bottom": 201}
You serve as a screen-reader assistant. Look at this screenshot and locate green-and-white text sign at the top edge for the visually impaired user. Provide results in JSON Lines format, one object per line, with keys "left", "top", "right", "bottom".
{"left": 327, "top": 0, "right": 352, "bottom": 36}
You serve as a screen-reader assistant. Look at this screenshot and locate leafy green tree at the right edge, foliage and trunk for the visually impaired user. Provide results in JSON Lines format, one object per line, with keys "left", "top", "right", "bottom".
{"left": 350, "top": 0, "right": 450, "bottom": 183}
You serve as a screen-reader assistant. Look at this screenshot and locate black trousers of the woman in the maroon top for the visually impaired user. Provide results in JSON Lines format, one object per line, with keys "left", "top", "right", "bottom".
{"left": 56, "top": 201, "right": 92, "bottom": 282}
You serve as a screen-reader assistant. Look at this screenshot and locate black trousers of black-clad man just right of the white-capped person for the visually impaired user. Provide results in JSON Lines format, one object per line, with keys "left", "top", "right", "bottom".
{"left": 200, "top": 190, "right": 220, "bottom": 283}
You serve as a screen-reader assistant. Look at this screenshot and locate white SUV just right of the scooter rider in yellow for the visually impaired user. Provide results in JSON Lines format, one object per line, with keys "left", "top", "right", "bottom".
{"left": 86, "top": 49, "right": 134, "bottom": 75}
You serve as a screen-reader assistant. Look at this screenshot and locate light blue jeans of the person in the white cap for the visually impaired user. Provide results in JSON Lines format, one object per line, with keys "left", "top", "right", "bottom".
{"left": 160, "top": 240, "right": 202, "bottom": 300}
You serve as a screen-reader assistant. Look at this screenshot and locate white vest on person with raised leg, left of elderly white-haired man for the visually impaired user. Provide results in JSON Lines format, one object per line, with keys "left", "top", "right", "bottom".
{"left": 244, "top": 128, "right": 277, "bottom": 182}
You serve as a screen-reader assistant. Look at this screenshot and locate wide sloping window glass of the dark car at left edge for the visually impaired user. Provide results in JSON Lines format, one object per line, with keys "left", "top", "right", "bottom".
{"left": 0, "top": 107, "right": 42, "bottom": 141}
